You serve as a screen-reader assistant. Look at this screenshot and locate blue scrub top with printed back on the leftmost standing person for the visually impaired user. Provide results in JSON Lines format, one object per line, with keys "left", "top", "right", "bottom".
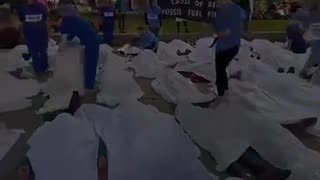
{"left": 19, "top": 3, "right": 48, "bottom": 46}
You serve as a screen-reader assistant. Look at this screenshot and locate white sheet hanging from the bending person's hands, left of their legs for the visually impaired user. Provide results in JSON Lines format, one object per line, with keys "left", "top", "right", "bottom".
{"left": 38, "top": 45, "right": 84, "bottom": 114}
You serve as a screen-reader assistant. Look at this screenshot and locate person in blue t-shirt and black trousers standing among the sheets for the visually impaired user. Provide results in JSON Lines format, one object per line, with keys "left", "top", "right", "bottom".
{"left": 214, "top": 0, "right": 243, "bottom": 97}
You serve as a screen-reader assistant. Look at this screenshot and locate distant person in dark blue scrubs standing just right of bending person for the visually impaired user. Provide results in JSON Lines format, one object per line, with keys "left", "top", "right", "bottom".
{"left": 99, "top": 0, "right": 116, "bottom": 46}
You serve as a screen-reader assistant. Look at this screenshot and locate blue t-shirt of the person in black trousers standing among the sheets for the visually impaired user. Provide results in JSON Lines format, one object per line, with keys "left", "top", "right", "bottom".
{"left": 214, "top": 3, "right": 245, "bottom": 52}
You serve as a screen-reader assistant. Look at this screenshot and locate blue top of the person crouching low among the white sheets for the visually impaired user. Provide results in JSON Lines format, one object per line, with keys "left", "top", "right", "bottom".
{"left": 134, "top": 31, "right": 159, "bottom": 50}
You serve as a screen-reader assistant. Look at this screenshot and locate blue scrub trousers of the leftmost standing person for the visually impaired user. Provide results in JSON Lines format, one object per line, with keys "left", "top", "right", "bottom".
{"left": 27, "top": 43, "right": 49, "bottom": 74}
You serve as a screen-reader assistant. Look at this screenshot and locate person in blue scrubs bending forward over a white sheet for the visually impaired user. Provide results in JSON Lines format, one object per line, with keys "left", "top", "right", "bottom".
{"left": 50, "top": 11, "right": 100, "bottom": 90}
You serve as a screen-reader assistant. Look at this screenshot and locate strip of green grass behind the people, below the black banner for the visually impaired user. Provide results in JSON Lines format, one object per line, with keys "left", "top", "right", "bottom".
{"left": 84, "top": 15, "right": 289, "bottom": 33}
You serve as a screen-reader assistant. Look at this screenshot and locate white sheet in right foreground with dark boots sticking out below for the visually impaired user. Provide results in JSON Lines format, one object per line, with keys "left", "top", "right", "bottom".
{"left": 176, "top": 88, "right": 320, "bottom": 180}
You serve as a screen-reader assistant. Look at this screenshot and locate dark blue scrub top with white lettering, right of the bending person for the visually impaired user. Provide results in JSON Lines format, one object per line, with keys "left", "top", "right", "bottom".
{"left": 99, "top": 6, "right": 116, "bottom": 32}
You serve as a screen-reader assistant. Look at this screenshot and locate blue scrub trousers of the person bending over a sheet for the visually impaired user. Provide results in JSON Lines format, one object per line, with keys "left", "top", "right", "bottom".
{"left": 84, "top": 42, "right": 100, "bottom": 89}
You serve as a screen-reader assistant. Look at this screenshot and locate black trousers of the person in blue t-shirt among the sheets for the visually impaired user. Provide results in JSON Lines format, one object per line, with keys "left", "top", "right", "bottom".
{"left": 216, "top": 46, "right": 239, "bottom": 96}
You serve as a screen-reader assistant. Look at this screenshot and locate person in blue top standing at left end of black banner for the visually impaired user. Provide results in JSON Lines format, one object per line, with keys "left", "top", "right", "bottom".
{"left": 145, "top": 0, "right": 162, "bottom": 36}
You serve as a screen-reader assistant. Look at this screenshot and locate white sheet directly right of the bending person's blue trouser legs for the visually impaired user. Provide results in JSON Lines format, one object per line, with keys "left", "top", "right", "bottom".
{"left": 97, "top": 53, "right": 144, "bottom": 106}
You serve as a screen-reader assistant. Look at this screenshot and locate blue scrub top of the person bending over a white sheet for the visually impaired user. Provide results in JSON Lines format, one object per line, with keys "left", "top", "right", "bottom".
{"left": 60, "top": 16, "right": 99, "bottom": 45}
